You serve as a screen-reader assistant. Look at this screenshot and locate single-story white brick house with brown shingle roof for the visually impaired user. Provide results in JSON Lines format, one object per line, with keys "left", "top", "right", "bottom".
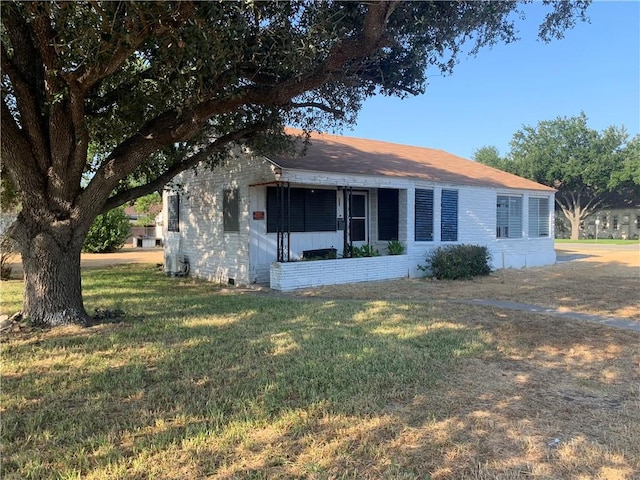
{"left": 163, "top": 129, "right": 555, "bottom": 290}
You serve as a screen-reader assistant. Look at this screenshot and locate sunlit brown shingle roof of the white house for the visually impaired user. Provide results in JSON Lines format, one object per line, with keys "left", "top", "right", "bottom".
{"left": 270, "top": 130, "right": 554, "bottom": 191}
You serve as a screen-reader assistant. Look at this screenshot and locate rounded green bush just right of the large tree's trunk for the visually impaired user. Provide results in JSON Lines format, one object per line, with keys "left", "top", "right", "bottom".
{"left": 82, "top": 207, "right": 131, "bottom": 253}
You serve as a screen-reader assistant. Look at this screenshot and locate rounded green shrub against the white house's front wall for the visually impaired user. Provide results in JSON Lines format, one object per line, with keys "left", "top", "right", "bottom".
{"left": 418, "top": 245, "right": 491, "bottom": 280}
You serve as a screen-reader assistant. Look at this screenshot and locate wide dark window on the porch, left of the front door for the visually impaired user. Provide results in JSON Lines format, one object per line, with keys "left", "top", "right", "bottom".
{"left": 267, "top": 187, "right": 336, "bottom": 233}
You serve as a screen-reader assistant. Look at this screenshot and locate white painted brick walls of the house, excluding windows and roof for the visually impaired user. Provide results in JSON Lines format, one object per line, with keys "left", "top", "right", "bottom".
{"left": 163, "top": 155, "right": 555, "bottom": 289}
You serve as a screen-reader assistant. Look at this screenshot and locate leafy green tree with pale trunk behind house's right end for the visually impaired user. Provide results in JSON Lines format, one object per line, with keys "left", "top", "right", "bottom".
{"left": 476, "top": 113, "right": 640, "bottom": 239}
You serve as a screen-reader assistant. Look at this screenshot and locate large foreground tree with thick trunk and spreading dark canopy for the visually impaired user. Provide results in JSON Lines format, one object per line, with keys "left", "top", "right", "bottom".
{"left": 0, "top": 0, "right": 589, "bottom": 325}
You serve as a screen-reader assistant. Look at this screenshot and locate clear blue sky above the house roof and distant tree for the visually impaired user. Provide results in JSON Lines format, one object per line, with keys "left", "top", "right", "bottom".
{"left": 342, "top": 1, "right": 640, "bottom": 158}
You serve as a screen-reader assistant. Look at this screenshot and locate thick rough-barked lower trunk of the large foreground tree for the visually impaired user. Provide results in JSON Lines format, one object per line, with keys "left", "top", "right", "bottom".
{"left": 11, "top": 219, "right": 89, "bottom": 327}
